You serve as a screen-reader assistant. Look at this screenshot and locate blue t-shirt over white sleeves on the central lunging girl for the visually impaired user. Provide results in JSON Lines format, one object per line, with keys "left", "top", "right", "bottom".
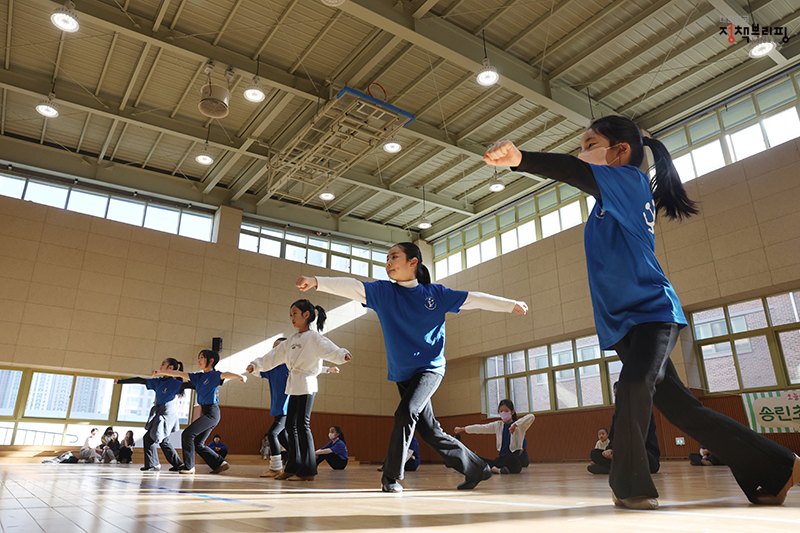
{"left": 364, "top": 281, "right": 467, "bottom": 382}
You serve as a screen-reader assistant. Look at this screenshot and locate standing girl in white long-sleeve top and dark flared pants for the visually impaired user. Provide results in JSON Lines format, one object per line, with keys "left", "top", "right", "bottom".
{"left": 247, "top": 300, "right": 352, "bottom": 481}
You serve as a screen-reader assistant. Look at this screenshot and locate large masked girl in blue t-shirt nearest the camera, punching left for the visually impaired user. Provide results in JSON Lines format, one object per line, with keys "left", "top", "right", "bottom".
{"left": 484, "top": 116, "right": 800, "bottom": 509}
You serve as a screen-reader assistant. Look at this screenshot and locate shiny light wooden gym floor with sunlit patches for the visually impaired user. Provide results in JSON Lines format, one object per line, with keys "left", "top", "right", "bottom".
{"left": 0, "top": 461, "right": 800, "bottom": 533}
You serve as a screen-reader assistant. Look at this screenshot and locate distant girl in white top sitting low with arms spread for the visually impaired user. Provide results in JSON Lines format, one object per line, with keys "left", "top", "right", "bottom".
{"left": 455, "top": 399, "right": 536, "bottom": 474}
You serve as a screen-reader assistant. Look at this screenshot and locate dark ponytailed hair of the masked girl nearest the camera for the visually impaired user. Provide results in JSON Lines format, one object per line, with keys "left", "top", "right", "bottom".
{"left": 589, "top": 115, "right": 698, "bottom": 220}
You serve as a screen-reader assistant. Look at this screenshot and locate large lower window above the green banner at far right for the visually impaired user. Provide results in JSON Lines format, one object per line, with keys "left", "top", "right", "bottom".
{"left": 691, "top": 291, "right": 800, "bottom": 393}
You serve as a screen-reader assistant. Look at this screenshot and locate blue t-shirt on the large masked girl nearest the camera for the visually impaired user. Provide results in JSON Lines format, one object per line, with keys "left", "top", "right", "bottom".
{"left": 583, "top": 165, "right": 686, "bottom": 350}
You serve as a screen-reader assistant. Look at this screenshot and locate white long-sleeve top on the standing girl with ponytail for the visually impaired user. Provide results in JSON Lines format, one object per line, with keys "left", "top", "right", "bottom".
{"left": 250, "top": 330, "right": 350, "bottom": 396}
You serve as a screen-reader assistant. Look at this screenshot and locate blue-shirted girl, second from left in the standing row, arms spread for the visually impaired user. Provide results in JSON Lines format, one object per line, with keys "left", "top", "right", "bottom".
{"left": 153, "top": 350, "right": 247, "bottom": 474}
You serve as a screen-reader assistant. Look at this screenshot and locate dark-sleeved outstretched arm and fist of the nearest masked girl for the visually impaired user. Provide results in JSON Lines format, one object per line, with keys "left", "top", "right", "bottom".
{"left": 483, "top": 141, "right": 600, "bottom": 200}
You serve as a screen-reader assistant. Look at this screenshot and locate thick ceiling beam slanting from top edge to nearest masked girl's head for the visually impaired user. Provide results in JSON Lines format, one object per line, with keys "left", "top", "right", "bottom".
{"left": 340, "top": 0, "right": 614, "bottom": 126}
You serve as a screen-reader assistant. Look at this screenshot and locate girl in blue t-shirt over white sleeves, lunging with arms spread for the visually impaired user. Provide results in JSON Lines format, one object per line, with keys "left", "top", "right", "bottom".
{"left": 296, "top": 242, "right": 528, "bottom": 492}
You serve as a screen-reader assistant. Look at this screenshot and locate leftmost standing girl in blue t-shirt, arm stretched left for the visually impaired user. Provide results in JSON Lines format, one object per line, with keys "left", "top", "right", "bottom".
{"left": 114, "top": 357, "right": 191, "bottom": 472}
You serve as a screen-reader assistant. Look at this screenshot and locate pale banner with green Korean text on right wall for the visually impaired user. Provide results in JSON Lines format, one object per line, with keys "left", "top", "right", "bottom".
{"left": 742, "top": 390, "right": 800, "bottom": 433}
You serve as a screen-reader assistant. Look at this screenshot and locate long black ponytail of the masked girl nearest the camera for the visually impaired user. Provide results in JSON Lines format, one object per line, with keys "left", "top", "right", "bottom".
{"left": 643, "top": 137, "right": 698, "bottom": 220}
